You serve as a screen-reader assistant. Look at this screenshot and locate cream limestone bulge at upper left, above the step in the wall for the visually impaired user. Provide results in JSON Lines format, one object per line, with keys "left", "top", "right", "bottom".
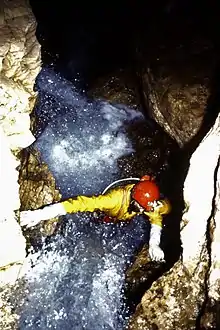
{"left": 0, "top": 1, "right": 41, "bottom": 150}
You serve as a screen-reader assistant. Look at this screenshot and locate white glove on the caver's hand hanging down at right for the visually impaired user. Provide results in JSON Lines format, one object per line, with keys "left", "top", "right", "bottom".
{"left": 149, "top": 224, "right": 165, "bottom": 262}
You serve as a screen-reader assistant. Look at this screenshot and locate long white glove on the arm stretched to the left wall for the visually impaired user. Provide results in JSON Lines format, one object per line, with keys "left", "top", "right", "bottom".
{"left": 20, "top": 203, "right": 66, "bottom": 228}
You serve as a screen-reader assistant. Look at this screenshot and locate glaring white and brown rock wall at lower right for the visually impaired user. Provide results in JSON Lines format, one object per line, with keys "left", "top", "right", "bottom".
{"left": 128, "top": 115, "right": 220, "bottom": 330}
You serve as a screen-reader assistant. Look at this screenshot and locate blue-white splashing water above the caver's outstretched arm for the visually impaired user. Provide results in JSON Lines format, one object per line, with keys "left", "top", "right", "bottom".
{"left": 35, "top": 66, "right": 144, "bottom": 198}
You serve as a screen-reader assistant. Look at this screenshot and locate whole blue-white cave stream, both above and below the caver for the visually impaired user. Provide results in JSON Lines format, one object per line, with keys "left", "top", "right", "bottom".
{"left": 7, "top": 69, "right": 174, "bottom": 330}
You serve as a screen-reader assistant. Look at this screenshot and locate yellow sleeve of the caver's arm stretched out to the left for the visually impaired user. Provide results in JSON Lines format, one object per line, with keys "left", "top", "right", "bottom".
{"left": 61, "top": 194, "right": 117, "bottom": 213}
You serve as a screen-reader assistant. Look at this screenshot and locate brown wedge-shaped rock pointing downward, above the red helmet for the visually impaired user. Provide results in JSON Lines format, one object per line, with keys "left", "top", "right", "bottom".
{"left": 143, "top": 70, "right": 209, "bottom": 147}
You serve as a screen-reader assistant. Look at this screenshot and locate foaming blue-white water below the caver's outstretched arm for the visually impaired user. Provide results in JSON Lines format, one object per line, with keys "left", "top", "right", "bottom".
{"left": 17, "top": 215, "right": 147, "bottom": 330}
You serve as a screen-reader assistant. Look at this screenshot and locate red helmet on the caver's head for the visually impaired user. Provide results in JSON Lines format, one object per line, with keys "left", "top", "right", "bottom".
{"left": 132, "top": 175, "right": 160, "bottom": 211}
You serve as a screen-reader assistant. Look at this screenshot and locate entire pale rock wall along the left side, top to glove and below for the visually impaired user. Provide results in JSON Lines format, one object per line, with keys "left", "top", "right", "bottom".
{"left": 0, "top": 0, "right": 41, "bottom": 285}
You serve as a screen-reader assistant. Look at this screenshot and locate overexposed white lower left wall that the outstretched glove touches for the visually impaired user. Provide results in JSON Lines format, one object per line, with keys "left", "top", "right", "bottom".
{"left": 0, "top": 127, "right": 26, "bottom": 274}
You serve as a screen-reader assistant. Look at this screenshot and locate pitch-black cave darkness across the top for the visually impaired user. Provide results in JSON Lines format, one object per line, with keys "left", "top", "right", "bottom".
{"left": 30, "top": 0, "right": 220, "bottom": 85}
